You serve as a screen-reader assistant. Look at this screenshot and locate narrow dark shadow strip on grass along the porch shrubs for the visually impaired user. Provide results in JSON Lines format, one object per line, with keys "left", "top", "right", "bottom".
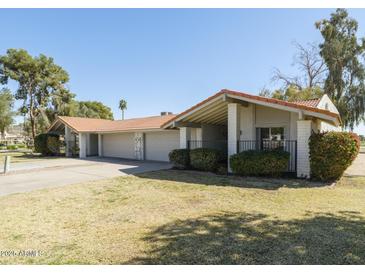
{"left": 135, "top": 169, "right": 329, "bottom": 190}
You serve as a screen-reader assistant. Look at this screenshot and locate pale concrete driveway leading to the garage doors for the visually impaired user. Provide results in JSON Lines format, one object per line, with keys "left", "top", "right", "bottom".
{"left": 0, "top": 158, "right": 170, "bottom": 196}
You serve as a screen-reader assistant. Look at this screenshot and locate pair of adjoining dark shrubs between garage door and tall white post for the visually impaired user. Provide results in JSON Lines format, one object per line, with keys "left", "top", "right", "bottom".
{"left": 169, "top": 148, "right": 224, "bottom": 172}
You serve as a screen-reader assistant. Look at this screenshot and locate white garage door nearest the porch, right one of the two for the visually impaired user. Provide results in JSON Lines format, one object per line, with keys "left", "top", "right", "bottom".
{"left": 145, "top": 130, "right": 180, "bottom": 161}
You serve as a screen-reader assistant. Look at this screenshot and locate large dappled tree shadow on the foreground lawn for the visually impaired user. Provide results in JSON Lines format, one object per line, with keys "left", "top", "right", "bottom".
{"left": 127, "top": 211, "right": 365, "bottom": 264}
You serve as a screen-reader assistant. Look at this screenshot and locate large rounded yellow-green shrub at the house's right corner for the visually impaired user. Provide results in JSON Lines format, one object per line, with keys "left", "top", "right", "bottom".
{"left": 309, "top": 132, "right": 359, "bottom": 182}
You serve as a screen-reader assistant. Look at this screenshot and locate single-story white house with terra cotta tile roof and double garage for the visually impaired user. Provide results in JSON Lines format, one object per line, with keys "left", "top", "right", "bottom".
{"left": 49, "top": 89, "right": 341, "bottom": 177}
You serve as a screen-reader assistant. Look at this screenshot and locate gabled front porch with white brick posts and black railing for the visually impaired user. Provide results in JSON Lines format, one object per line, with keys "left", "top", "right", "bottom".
{"left": 166, "top": 91, "right": 318, "bottom": 178}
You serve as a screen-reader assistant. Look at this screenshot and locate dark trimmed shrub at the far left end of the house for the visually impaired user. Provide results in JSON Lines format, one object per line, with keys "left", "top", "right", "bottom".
{"left": 34, "top": 133, "right": 61, "bottom": 156}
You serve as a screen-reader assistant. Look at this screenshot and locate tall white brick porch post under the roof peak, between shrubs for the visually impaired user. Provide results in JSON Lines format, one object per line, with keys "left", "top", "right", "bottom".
{"left": 228, "top": 103, "right": 240, "bottom": 172}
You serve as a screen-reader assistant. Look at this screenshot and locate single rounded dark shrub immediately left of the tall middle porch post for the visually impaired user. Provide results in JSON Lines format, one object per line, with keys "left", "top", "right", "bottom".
{"left": 190, "top": 148, "right": 223, "bottom": 172}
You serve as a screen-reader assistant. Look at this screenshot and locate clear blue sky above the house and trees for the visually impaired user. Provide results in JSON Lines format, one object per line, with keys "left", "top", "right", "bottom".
{"left": 0, "top": 9, "right": 365, "bottom": 134}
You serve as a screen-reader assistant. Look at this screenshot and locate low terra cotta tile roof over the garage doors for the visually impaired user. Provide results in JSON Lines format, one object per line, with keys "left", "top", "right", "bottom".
{"left": 57, "top": 115, "right": 175, "bottom": 132}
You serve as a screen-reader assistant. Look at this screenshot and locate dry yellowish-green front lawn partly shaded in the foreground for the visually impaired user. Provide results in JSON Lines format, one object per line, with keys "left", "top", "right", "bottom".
{"left": 0, "top": 170, "right": 365, "bottom": 264}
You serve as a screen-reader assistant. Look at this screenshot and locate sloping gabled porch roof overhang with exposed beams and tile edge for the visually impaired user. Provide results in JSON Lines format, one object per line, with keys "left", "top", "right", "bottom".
{"left": 162, "top": 89, "right": 341, "bottom": 128}
